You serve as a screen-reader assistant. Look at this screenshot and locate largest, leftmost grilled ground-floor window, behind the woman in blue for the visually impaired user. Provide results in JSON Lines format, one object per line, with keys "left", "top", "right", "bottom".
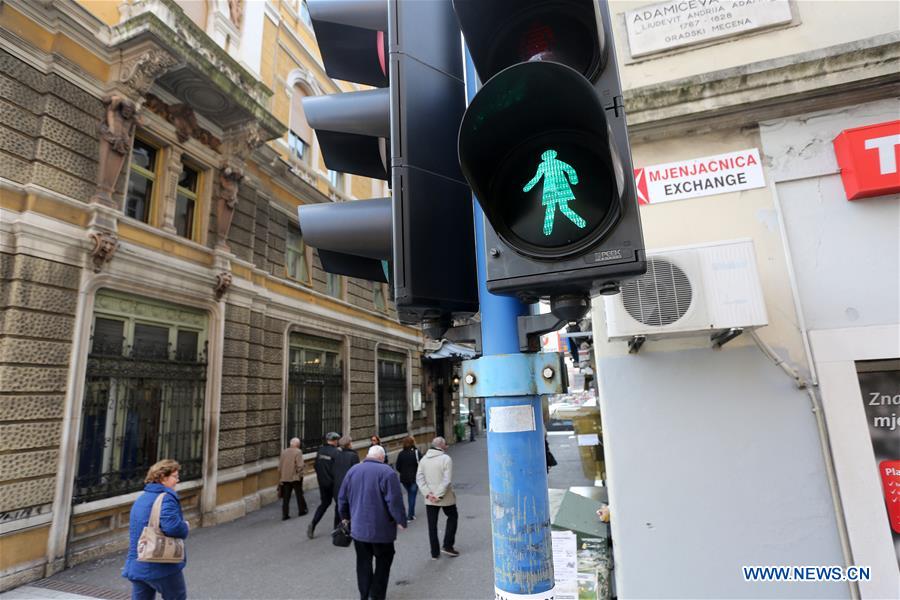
{"left": 73, "top": 291, "right": 207, "bottom": 504}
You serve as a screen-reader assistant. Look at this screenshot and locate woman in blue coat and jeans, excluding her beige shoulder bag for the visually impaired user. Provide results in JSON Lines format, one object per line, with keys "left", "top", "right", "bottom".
{"left": 122, "top": 458, "right": 191, "bottom": 600}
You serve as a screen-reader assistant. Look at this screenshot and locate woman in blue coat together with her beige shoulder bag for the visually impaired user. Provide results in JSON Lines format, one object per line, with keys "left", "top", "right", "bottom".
{"left": 122, "top": 459, "right": 190, "bottom": 600}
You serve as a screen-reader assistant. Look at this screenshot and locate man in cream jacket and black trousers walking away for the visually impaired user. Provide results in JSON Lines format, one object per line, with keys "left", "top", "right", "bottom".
{"left": 416, "top": 437, "right": 459, "bottom": 559}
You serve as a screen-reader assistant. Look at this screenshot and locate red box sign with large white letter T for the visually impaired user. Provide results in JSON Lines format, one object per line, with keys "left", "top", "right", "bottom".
{"left": 834, "top": 121, "right": 900, "bottom": 200}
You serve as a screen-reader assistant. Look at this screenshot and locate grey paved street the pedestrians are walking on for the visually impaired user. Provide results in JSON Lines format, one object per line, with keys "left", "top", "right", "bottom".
{"left": 0, "top": 433, "right": 590, "bottom": 600}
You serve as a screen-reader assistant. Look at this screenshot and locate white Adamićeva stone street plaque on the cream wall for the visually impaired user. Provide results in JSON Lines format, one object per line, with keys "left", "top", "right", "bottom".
{"left": 625, "top": 0, "right": 792, "bottom": 57}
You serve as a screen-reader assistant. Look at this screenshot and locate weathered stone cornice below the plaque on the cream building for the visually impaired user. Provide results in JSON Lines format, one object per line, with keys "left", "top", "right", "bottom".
{"left": 625, "top": 32, "right": 900, "bottom": 141}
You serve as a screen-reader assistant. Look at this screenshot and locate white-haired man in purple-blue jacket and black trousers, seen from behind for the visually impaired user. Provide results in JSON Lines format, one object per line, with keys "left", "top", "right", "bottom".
{"left": 338, "top": 446, "right": 406, "bottom": 600}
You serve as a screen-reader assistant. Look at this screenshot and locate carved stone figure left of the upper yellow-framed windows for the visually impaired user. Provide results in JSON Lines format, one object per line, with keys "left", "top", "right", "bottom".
{"left": 91, "top": 94, "right": 138, "bottom": 208}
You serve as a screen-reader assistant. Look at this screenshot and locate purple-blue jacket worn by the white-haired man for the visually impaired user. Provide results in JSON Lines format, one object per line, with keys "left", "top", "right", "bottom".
{"left": 338, "top": 458, "right": 406, "bottom": 544}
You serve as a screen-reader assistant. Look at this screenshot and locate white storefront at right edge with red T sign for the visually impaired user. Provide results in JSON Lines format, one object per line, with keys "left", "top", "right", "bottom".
{"left": 760, "top": 99, "right": 900, "bottom": 597}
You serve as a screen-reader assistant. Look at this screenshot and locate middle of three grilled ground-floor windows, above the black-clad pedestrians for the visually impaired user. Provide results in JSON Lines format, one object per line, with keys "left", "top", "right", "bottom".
{"left": 284, "top": 333, "right": 344, "bottom": 452}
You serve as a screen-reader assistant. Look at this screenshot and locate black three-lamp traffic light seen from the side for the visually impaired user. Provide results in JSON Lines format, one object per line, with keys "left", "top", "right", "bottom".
{"left": 299, "top": 0, "right": 478, "bottom": 324}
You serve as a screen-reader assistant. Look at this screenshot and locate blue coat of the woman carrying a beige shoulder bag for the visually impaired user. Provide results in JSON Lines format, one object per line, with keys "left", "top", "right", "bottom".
{"left": 122, "top": 483, "right": 190, "bottom": 581}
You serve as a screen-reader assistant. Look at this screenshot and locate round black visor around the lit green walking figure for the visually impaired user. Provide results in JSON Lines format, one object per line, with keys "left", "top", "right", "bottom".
{"left": 459, "top": 62, "right": 624, "bottom": 259}
